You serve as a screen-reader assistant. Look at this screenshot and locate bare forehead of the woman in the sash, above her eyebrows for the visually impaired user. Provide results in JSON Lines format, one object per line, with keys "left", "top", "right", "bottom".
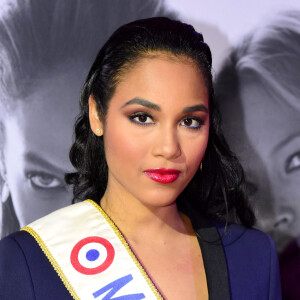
{"left": 113, "top": 57, "right": 207, "bottom": 108}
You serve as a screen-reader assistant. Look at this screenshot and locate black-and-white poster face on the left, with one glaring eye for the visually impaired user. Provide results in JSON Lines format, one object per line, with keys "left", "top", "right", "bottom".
{"left": 3, "top": 71, "right": 82, "bottom": 227}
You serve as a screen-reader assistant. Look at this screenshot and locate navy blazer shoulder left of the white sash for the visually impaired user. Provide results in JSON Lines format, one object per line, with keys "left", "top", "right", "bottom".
{"left": 0, "top": 231, "right": 71, "bottom": 300}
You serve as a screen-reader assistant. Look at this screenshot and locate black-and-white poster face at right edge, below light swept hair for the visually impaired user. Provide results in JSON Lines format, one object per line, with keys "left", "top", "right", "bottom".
{"left": 222, "top": 79, "right": 300, "bottom": 250}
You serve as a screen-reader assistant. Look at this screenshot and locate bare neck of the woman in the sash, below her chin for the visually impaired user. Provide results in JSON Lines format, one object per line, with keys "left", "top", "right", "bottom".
{"left": 100, "top": 190, "right": 193, "bottom": 242}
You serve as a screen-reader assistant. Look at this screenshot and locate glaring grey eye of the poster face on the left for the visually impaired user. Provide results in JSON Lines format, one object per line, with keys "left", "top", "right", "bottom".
{"left": 27, "top": 173, "right": 65, "bottom": 189}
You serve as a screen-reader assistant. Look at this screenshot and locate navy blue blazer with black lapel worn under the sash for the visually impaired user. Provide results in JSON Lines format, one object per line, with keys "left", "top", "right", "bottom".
{"left": 0, "top": 222, "right": 281, "bottom": 300}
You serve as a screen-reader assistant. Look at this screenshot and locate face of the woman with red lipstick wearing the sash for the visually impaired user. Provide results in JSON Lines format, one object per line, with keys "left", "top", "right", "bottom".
{"left": 92, "top": 55, "right": 209, "bottom": 207}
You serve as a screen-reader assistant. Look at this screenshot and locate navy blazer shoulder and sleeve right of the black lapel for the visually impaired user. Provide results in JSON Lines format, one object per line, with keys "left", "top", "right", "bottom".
{"left": 217, "top": 224, "right": 281, "bottom": 299}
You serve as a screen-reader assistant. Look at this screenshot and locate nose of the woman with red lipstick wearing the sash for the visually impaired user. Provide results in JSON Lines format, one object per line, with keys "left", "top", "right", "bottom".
{"left": 152, "top": 129, "right": 181, "bottom": 160}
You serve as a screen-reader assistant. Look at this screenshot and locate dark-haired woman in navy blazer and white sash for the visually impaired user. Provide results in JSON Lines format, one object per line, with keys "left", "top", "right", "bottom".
{"left": 0, "top": 18, "right": 280, "bottom": 300}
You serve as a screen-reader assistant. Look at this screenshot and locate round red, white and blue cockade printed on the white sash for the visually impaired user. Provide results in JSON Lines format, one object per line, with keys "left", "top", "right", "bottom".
{"left": 70, "top": 236, "right": 115, "bottom": 275}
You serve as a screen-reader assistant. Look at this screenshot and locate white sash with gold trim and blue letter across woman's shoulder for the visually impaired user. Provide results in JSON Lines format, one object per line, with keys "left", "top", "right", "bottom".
{"left": 22, "top": 200, "right": 163, "bottom": 300}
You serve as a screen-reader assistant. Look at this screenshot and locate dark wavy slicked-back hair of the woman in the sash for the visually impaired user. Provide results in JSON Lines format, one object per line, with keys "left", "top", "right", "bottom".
{"left": 66, "top": 17, "right": 255, "bottom": 227}
